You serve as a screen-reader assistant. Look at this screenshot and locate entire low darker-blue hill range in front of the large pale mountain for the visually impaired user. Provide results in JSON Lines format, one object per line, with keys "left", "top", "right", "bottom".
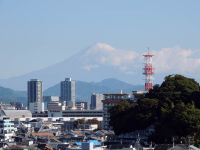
{"left": 0, "top": 78, "right": 144, "bottom": 105}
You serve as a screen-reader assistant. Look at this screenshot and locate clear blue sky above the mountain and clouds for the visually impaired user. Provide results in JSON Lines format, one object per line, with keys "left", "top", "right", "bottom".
{"left": 0, "top": 0, "right": 200, "bottom": 78}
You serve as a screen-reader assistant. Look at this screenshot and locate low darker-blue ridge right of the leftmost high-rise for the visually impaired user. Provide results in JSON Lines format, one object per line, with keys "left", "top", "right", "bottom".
{"left": 43, "top": 78, "right": 144, "bottom": 101}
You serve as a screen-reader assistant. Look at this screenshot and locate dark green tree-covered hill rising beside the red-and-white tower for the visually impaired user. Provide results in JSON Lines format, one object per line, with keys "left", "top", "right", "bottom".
{"left": 110, "top": 75, "right": 200, "bottom": 145}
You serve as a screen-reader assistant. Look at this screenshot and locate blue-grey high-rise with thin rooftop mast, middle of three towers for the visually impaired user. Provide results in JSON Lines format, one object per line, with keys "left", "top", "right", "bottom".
{"left": 60, "top": 78, "right": 75, "bottom": 108}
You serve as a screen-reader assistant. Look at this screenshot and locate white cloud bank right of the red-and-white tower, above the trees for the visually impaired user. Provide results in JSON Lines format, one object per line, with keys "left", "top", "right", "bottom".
{"left": 153, "top": 46, "right": 200, "bottom": 74}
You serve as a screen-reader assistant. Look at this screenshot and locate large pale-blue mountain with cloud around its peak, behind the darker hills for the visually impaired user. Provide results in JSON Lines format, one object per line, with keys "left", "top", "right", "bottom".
{"left": 0, "top": 43, "right": 144, "bottom": 90}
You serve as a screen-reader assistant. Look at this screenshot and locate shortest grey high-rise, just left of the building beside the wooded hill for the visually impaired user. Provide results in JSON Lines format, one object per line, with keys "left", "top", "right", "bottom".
{"left": 90, "top": 93, "right": 103, "bottom": 110}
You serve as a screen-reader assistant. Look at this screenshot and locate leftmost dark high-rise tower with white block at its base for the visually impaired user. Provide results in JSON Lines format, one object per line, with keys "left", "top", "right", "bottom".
{"left": 27, "top": 79, "right": 44, "bottom": 113}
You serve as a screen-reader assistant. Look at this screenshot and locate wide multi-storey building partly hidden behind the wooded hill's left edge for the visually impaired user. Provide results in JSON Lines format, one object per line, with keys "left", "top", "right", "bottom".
{"left": 102, "top": 93, "right": 131, "bottom": 130}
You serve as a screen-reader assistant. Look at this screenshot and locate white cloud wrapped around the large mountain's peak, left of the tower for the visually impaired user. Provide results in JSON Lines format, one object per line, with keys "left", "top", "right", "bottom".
{"left": 83, "top": 43, "right": 138, "bottom": 71}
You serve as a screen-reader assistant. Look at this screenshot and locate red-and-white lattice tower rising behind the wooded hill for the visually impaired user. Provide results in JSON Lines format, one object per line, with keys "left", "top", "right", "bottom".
{"left": 143, "top": 48, "right": 154, "bottom": 91}
